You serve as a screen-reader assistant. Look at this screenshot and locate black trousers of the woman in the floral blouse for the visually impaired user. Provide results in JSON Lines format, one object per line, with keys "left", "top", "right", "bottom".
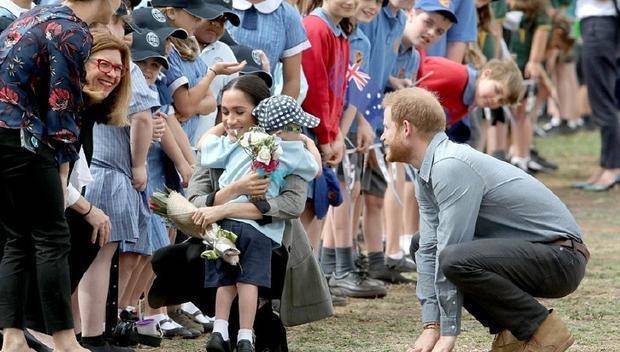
{"left": 0, "top": 146, "right": 73, "bottom": 333}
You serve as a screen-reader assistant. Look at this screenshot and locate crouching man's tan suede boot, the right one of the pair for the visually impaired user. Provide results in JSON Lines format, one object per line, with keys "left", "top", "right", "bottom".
{"left": 524, "top": 312, "right": 575, "bottom": 352}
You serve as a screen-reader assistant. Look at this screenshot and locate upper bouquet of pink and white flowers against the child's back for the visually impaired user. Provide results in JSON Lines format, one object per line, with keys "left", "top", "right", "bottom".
{"left": 239, "top": 127, "right": 283, "bottom": 199}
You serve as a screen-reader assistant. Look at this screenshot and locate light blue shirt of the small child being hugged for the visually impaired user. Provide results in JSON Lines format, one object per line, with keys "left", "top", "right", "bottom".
{"left": 201, "top": 135, "right": 319, "bottom": 245}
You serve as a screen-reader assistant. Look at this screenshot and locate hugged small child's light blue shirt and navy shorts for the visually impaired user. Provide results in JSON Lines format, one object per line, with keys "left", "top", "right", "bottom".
{"left": 201, "top": 135, "right": 319, "bottom": 287}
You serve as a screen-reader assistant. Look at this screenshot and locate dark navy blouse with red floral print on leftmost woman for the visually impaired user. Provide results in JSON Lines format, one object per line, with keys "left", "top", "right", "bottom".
{"left": 0, "top": 5, "right": 92, "bottom": 163}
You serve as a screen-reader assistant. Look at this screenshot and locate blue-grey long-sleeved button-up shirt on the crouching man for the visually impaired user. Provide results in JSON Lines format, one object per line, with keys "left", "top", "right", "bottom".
{"left": 415, "top": 133, "right": 581, "bottom": 335}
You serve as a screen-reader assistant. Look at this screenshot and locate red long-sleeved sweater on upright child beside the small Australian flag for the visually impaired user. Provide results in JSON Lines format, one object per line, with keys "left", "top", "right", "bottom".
{"left": 302, "top": 8, "right": 349, "bottom": 144}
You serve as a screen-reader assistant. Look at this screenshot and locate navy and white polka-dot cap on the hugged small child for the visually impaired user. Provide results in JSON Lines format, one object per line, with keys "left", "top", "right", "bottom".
{"left": 252, "top": 95, "right": 321, "bottom": 131}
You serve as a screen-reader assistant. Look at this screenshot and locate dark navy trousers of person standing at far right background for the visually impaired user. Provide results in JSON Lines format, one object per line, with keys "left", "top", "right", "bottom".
{"left": 581, "top": 16, "right": 620, "bottom": 169}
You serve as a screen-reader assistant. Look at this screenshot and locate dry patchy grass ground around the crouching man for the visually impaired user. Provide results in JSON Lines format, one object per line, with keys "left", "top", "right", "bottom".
{"left": 156, "top": 133, "right": 620, "bottom": 352}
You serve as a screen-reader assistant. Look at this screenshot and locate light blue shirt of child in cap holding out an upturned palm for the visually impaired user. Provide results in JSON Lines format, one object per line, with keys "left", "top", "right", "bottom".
{"left": 165, "top": 48, "right": 209, "bottom": 145}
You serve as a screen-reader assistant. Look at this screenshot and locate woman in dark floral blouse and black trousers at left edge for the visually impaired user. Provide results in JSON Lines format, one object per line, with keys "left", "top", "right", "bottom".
{"left": 0, "top": 0, "right": 120, "bottom": 352}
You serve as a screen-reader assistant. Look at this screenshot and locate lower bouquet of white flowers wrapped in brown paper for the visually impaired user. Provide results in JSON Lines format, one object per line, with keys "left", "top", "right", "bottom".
{"left": 149, "top": 189, "right": 241, "bottom": 265}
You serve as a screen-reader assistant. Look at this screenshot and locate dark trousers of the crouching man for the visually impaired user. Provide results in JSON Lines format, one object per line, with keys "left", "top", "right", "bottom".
{"left": 439, "top": 239, "right": 587, "bottom": 340}
